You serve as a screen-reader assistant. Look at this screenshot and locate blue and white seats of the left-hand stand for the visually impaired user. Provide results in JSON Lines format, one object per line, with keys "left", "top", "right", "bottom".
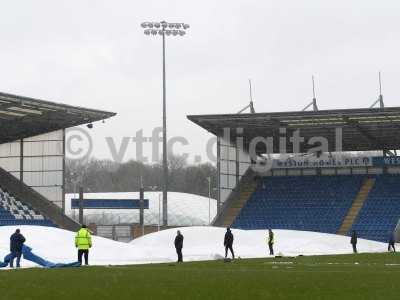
{"left": 0, "top": 187, "right": 55, "bottom": 226}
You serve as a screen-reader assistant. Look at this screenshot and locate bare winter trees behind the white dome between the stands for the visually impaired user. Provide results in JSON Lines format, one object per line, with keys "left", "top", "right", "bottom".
{"left": 65, "top": 156, "right": 217, "bottom": 199}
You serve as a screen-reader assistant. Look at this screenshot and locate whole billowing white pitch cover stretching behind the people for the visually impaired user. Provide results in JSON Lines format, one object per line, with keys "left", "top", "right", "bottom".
{"left": 0, "top": 226, "right": 386, "bottom": 267}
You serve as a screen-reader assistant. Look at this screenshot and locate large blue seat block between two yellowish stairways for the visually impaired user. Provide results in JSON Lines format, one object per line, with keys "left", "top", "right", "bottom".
{"left": 232, "top": 175, "right": 363, "bottom": 233}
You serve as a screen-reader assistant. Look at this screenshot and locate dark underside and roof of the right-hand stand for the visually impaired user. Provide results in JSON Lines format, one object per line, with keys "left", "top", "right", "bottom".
{"left": 188, "top": 107, "right": 400, "bottom": 153}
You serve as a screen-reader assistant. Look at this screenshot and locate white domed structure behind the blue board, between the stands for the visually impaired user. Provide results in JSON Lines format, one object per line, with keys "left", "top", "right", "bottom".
{"left": 65, "top": 191, "right": 217, "bottom": 226}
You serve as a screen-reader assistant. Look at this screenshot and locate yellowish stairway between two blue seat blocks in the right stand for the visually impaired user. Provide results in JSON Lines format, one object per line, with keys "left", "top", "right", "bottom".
{"left": 337, "top": 178, "right": 375, "bottom": 235}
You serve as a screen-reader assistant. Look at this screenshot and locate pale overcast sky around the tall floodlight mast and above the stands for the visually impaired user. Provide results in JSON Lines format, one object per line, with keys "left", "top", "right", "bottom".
{"left": 0, "top": 0, "right": 400, "bottom": 164}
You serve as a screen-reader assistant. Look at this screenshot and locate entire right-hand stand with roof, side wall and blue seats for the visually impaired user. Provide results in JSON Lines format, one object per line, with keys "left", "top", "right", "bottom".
{"left": 187, "top": 106, "right": 400, "bottom": 241}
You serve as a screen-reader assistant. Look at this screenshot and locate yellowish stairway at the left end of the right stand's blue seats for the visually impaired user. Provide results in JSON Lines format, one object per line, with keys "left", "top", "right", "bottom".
{"left": 213, "top": 168, "right": 257, "bottom": 227}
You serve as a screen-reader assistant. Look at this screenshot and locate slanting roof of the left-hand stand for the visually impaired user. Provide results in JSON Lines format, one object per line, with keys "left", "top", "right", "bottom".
{"left": 0, "top": 92, "right": 116, "bottom": 144}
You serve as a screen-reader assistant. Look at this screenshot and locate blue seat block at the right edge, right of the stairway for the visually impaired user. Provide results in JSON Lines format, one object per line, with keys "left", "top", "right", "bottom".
{"left": 352, "top": 174, "right": 400, "bottom": 242}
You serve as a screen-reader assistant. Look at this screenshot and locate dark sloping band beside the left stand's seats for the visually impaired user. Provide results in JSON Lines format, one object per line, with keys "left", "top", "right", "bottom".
{"left": 0, "top": 168, "right": 80, "bottom": 231}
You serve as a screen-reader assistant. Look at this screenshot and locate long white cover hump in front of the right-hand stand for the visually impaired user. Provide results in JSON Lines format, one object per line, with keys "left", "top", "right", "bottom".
{"left": 130, "top": 226, "right": 386, "bottom": 260}
